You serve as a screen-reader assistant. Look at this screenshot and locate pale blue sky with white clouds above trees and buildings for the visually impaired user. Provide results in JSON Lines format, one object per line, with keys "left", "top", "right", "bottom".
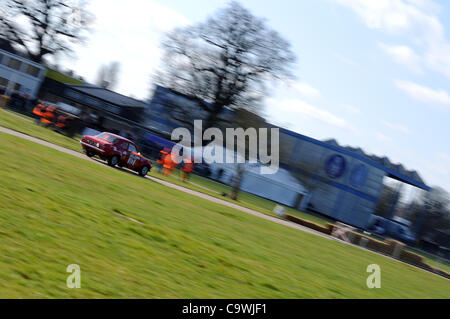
{"left": 60, "top": 0, "right": 450, "bottom": 196}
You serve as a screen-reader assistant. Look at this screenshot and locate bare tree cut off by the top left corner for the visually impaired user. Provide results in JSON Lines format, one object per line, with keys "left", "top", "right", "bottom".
{"left": 0, "top": 0, "right": 93, "bottom": 63}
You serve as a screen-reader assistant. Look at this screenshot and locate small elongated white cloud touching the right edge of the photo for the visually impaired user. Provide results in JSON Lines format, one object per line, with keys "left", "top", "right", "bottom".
{"left": 394, "top": 80, "right": 450, "bottom": 108}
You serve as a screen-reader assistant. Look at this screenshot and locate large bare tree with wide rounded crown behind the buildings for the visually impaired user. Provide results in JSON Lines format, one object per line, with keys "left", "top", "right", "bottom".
{"left": 158, "top": 2, "right": 295, "bottom": 130}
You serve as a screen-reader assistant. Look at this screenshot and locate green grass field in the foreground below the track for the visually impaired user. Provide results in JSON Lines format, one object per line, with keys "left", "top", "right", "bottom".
{"left": 0, "top": 133, "right": 450, "bottom": 298}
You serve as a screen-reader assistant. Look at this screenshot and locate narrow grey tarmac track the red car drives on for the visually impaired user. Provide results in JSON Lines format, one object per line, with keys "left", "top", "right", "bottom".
{"left": 0, "top": 126, "right": 449, "bottom": 280}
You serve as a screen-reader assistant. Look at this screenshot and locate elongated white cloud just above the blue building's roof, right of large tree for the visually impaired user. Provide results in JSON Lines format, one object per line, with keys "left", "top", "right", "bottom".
{"left": 267, "top": 99, "right": 358, "bottom": 134}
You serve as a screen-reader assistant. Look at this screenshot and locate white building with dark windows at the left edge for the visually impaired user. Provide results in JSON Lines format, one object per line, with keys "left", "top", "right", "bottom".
{"left": 0, "top": 50, "right": 46, "bottom": 98}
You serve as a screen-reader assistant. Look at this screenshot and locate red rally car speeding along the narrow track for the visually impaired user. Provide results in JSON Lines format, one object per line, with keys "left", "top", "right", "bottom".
{"left": 80, "top": 132, "right": 153, "bottom": 176}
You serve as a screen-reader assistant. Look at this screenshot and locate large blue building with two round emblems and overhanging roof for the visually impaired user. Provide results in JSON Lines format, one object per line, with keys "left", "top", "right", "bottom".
{"left": 280, "top": 128, "right": 430, "bottom": 228}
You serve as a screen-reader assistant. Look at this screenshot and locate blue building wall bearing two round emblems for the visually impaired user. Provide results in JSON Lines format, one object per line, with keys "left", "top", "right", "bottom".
{"left": 280, "top": 133, "right": 386, "bottom": 228}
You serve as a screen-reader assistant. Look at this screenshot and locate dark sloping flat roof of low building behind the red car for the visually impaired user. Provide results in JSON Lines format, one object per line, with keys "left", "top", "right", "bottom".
{"left": 70, "top": 85, "right": 147, "bottom": 108}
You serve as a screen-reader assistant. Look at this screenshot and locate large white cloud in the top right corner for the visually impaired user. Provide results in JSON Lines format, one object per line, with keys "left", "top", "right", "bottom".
{"left": 335, "top": 0, "right": 450, "bottom": 78}
